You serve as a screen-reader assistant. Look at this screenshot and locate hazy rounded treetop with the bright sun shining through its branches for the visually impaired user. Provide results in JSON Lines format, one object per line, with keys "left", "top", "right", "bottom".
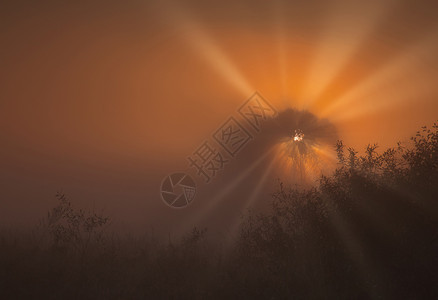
{"left": 250, "top": 108, "right": 338, "bottom": 186}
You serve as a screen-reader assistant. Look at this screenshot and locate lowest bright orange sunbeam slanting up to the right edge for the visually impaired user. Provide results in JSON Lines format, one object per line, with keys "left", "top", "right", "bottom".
{"left": 319, "top": 34, "right": 438, "bottom": 121}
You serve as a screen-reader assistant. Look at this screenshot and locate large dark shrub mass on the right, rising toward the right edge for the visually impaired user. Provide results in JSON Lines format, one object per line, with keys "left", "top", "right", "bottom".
{"left": 237, "top": 124, "right": 438, "bottom": 298}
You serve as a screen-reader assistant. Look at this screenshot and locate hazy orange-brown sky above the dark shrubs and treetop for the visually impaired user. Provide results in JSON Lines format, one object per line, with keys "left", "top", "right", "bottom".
{"left": 0, "top": 0, "right": 438, "bottom": 232}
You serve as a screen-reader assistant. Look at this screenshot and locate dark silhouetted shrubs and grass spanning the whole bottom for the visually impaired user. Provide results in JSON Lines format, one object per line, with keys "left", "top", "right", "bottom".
{"left": 0, "top": 124, "right": 438, "bottom": 299}
